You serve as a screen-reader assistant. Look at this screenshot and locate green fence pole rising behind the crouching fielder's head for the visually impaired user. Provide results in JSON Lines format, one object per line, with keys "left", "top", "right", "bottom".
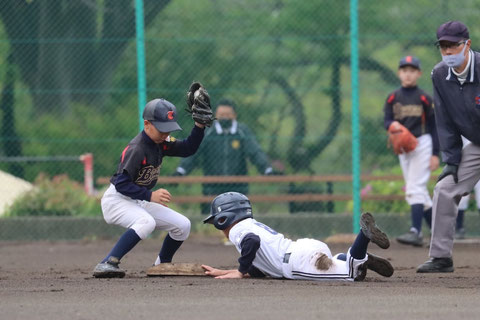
{"left": 135, "top": 0, "right": 147, "bottom": 131}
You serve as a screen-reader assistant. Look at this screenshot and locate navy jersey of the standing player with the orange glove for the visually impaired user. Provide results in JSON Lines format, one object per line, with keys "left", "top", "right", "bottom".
{"left": 383, "top": 86, "right": 439, "bottom": 155}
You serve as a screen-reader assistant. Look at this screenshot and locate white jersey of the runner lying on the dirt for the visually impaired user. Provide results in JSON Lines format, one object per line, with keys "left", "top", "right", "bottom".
{"left": 229, "top": 218, "right": 292, "bottom": 278}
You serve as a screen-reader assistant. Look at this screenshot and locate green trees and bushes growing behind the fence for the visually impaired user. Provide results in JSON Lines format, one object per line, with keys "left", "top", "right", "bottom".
{"left": 0, "top": 0, "right": 480, "bottom": 218}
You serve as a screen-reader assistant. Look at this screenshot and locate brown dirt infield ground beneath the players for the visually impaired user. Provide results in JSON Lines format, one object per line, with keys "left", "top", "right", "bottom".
{"left": 0, "top": 236, "right": 480, "bottom": 320}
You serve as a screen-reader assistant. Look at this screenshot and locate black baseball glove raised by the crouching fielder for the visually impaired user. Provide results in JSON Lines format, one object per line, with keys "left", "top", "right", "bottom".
{"left": 187, "top": 82, "right": 215, "bottom": 127}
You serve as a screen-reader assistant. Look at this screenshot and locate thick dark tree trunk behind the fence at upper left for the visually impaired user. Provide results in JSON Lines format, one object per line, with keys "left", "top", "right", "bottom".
{"left": 0, "top": 0, "right": 170, "bottom": 114}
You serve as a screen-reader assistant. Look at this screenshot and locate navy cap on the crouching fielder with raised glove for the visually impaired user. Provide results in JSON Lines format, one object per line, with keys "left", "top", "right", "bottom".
{"left": 143, "top": 99, "right": 182, "bottom": 132}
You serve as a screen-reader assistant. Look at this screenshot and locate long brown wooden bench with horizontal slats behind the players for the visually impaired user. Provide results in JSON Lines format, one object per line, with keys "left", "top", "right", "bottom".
{"left": 97, "top": 175, "right": 436, "bottom": 203}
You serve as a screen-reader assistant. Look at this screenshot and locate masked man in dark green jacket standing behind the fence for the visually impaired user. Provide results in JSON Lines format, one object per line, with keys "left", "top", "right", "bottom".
{"left": 174, "top": 99, "right": 274, "bottom": 214}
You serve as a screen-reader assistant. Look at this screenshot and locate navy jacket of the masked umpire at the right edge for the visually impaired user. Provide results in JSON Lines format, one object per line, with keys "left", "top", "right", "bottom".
{"left": 432, "top": 51, "right": 480, "bottom": 165}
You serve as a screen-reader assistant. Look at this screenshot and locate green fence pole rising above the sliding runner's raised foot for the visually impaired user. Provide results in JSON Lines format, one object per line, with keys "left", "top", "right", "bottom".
{"left": 350, "top": 0, "right": 361, "bottom": 233}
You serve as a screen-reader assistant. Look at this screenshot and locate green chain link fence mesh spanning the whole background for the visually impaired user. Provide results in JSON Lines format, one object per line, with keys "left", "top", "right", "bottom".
{"left": 0, "top": 0, "right": 480, "bottom": 240}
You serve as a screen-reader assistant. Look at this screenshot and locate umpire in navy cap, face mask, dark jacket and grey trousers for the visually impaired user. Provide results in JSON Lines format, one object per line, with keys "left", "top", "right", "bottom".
{"left": 417, "top": 21, "right": 480, "bottom": 273}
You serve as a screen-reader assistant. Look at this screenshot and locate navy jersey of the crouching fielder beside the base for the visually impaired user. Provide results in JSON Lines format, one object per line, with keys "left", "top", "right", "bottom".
{"left": 110, "top": 126, "right": 204, "bottom": 201}
